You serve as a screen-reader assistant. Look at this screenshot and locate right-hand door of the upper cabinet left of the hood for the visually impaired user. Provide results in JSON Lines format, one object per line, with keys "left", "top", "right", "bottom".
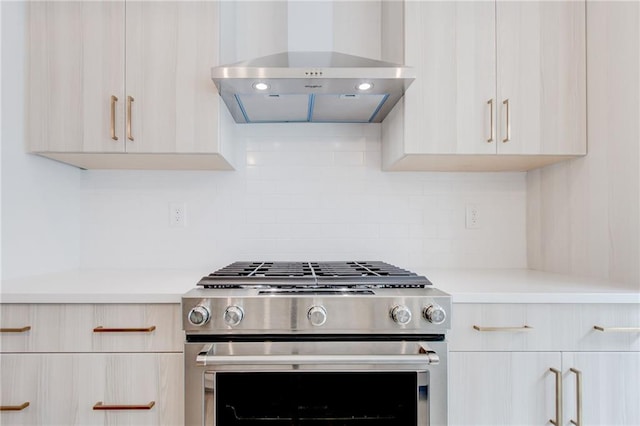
{"left": 126, "top": 1, "right": 221, "bottom": 153}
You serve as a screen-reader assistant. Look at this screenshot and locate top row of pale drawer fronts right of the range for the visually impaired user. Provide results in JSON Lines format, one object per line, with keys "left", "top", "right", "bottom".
{"left": 449, "top": 304, "right": 640, "bottom": 351}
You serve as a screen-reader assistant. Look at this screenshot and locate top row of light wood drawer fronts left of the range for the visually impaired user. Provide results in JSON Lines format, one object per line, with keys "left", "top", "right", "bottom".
{"left": 0, "top": 304, "right": 184, "bottom": 352}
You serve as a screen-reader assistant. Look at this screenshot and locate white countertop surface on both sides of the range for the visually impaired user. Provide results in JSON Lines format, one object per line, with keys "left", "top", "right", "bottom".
{"left": 0, "top": 269, "right": 640, "bottom": 303}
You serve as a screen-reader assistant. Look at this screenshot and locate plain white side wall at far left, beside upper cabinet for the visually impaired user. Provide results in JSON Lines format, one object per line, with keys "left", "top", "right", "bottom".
{"left": 0, "top": 2, "right": 81, "bottom": 279}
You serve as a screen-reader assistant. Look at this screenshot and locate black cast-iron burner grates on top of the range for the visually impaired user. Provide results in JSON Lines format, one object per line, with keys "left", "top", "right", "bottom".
{"left": 198, "top": 261, "right": 431, "bottom": 289}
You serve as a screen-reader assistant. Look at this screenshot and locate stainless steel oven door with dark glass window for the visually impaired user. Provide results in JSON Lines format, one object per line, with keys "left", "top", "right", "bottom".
{"left": 185, "top": 340, "right": 447, "bottom": 426}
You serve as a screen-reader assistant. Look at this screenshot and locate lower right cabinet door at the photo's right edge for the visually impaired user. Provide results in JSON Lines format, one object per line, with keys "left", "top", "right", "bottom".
{"left": 562, "top": 352, "right": 640, "bottom": 426}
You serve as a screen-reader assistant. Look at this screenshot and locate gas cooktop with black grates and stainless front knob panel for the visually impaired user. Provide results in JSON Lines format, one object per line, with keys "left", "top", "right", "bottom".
{"left": 182, "top": 261, "right": 451, "bottom": 336}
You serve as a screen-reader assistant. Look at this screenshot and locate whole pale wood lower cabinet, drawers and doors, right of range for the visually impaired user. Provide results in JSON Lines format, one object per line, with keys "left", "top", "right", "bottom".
{"left": 449, "top": 303, "right": 640, "bottom": 425}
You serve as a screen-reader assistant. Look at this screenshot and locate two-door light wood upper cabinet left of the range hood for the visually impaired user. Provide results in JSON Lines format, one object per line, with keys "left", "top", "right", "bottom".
{"left": 26, "top": 1, "right": 233, "bottom": 170}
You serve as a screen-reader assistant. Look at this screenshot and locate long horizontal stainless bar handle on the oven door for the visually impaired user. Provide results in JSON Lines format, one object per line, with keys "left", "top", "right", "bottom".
{"left": 196, "top": 348, "right": 440, "bottom": 367}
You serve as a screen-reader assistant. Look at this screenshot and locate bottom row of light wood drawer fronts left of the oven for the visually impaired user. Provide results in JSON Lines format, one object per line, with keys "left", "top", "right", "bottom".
{"left": 0, "top": 353, "right": 184, "bottom": 425}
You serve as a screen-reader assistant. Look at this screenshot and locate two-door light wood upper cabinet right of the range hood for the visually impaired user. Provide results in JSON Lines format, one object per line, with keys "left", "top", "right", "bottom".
{"left": 382, "top": 1, "right": 586, "bottom": 171}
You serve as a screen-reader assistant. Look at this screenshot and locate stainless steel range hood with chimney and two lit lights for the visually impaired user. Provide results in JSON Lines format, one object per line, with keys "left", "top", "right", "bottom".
{"left": 212, "top": 0, "right": 415, "bottom": 123}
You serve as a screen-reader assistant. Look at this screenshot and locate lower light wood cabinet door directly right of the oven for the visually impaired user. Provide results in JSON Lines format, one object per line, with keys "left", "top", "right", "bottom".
{"left": 449, "top": 352, "right": 561, "bottom": 426}
